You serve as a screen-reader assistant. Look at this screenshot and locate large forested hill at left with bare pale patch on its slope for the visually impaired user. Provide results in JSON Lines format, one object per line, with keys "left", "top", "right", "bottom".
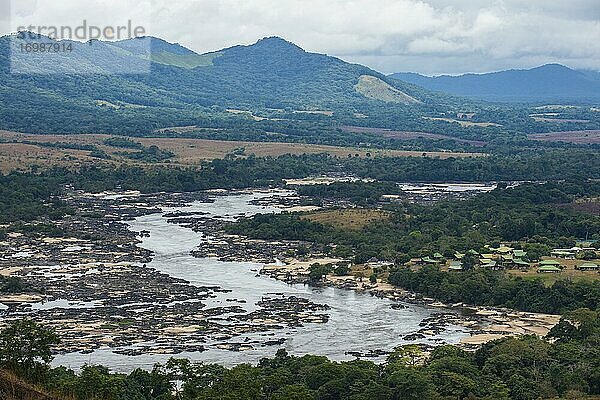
{"left": 0, "top": 35, "right": 436, "bottom": 132}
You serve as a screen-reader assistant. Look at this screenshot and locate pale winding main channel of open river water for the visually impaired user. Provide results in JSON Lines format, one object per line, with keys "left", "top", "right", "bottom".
{"left": 53, "top": 193, "right": 469, "bottom": 372}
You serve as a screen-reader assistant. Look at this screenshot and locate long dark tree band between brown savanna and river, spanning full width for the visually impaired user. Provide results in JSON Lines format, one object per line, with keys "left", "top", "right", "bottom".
{"left": 0, "top": 151, "right": 600, "bottom": 222}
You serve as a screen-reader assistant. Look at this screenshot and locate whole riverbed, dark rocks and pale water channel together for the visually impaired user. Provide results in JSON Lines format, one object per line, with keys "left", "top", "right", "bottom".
{"left": 0, "top": 191, "right": 556, "bottom": 371}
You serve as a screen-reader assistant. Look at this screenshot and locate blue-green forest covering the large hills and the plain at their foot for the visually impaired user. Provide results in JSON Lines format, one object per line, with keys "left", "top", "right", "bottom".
{"left": 0, "top": 33, "right": 600, "bottom": 150}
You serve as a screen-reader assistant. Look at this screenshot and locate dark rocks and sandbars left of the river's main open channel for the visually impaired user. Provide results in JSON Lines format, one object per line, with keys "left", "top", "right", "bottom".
{"left": 0, "top": 192, "right": 328, "bottom": 355}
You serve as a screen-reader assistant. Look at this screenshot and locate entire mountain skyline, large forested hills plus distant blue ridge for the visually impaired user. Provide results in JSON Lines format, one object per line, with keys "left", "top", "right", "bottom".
{"left": 0, "top": 31, "right": 600, "bottom": 138}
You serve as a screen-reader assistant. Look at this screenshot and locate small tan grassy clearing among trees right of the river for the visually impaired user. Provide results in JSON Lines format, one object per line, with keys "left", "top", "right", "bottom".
{"left": 302, "top": 208, "right": 390, "bottom": 231}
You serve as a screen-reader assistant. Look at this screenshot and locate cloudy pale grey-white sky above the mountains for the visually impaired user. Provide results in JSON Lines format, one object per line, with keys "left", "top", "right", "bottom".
{"left": 0, "top": 0, "right": 600, "bottom": 74}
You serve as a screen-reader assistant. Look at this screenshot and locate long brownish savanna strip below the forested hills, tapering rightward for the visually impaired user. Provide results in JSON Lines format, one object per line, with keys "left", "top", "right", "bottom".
{"left": 0, "top": 131, "right": 484, "bottom": 172}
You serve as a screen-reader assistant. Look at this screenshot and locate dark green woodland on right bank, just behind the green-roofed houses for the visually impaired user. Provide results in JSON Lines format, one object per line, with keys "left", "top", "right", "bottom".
{"left": 227, "top": 182, "right": 600, "bottom": 263}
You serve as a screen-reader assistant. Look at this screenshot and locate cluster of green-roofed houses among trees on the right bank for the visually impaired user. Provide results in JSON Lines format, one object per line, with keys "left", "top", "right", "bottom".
{"left": 410, "top": 246, "right": 600, "bottom": 273}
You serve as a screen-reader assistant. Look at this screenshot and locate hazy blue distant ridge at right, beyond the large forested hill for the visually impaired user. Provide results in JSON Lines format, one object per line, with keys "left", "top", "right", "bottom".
{"left": 390, "top": 64, "right": 600, "bottom": 103}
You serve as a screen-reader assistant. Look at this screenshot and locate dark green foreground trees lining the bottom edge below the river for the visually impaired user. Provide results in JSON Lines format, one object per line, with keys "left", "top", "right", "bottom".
{"left": 0, "top": 309, "right": 600, "bottom": 400}
